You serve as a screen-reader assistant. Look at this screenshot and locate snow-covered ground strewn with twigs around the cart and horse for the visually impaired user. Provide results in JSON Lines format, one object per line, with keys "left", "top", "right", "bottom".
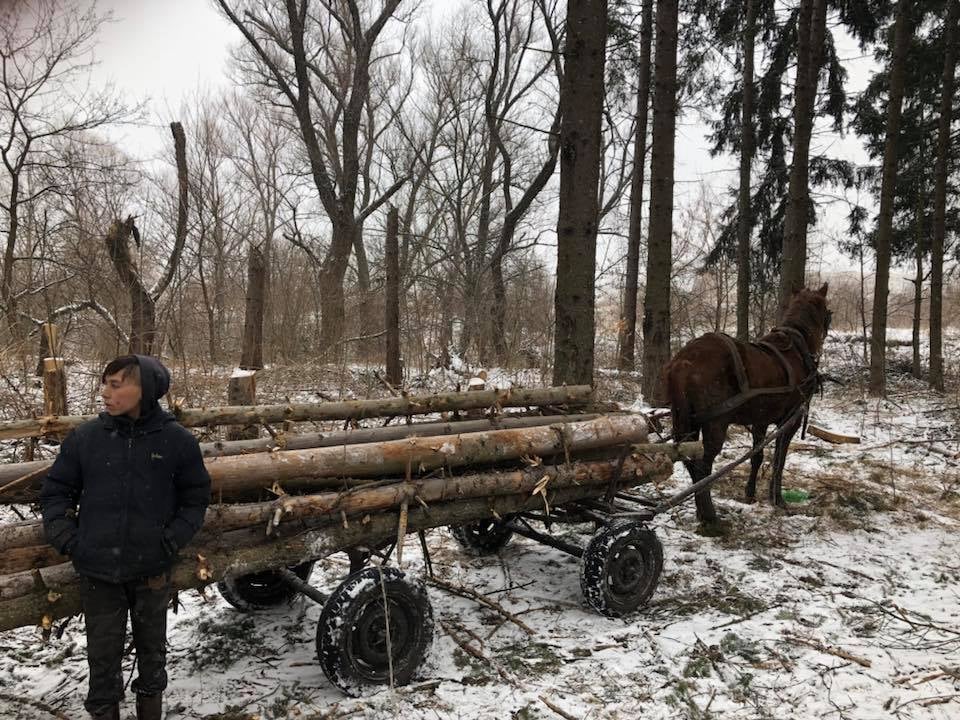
{"left": 0, "top": 338, "right": 960, "bottom": 720}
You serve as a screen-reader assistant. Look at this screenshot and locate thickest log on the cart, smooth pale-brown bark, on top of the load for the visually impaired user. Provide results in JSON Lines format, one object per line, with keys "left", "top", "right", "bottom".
{"left": 0, "top": 414, "right": 648, "bottom": 503}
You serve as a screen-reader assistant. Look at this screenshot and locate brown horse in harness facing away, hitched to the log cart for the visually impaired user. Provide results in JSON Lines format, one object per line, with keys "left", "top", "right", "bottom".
{"left": 663, "top": 283, "right": 831, "bottom": 523}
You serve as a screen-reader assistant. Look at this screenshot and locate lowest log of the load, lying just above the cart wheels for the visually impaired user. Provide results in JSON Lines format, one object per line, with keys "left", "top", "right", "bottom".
{"left": 0, "top": 461, "right": 672, "bottom": 632}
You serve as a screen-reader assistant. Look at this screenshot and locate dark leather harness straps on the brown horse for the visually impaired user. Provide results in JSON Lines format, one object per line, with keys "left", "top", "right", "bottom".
{"left": 696, "top": 325, "right": 821, "bottom": 428}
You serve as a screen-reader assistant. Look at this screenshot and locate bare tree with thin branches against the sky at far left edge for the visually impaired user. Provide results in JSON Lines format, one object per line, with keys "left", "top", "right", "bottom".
{"left": 0, "top": 0, "right": 134, "bottom": 332}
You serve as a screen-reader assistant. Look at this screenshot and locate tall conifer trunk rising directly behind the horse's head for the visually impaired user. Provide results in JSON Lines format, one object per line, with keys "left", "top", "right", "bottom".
{"left": 780, "top": 0, "right": 826, "bottom": 313}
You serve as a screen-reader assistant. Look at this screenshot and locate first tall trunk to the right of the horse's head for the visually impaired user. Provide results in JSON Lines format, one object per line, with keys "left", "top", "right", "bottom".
{"left": 868, "top": 0, "right": 912, "bottom": 396}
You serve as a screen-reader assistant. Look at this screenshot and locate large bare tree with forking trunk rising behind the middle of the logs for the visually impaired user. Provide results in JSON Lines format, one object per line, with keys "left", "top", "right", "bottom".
{"left": 217, "top": 0, "right": 406, "bottom": 348}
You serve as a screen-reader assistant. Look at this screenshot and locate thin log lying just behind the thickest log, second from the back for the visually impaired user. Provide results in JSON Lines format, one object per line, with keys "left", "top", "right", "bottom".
{"left": 0, "top": 414, "right": 599, "bottom": 504}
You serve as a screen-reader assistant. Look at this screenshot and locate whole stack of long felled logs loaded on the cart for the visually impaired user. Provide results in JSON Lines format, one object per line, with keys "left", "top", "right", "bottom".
{"left": 0, "top": 386, "right": 683, "bottom": 631}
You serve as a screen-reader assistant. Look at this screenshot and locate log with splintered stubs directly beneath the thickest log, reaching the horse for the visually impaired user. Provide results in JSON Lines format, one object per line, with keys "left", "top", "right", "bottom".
{"left": 0, "top": 443, "right": 688, "bottom": 576}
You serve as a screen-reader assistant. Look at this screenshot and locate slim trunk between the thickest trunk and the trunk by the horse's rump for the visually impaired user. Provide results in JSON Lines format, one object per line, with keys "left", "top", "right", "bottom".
{"left": 617, "top": 0, "right": 653, "bottom": 371}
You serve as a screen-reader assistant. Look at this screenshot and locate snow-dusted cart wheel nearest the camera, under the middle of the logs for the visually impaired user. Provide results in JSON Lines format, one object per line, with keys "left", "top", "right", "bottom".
{"left": 317, "top": 567, "right": 433, "bottom": 697}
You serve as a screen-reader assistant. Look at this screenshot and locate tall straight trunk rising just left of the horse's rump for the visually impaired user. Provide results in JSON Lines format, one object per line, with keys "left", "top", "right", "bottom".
{"left": 641, "top": 0, "right": 678, "bottom": 404}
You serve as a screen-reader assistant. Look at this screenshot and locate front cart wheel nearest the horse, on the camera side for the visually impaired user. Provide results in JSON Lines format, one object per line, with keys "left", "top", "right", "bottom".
{"left": 580, "top": 522, "right": 663, "bottom": 617}
